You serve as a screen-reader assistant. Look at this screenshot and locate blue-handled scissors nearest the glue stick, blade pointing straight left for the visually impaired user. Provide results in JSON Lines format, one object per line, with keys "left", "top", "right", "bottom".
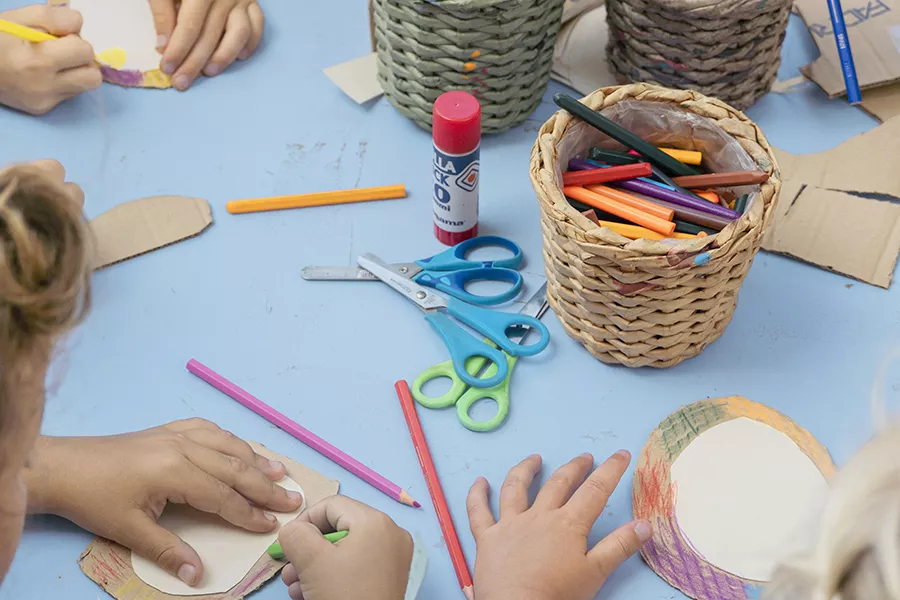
{"left": 303, "top": 235, "right": 523, "bottom": 306}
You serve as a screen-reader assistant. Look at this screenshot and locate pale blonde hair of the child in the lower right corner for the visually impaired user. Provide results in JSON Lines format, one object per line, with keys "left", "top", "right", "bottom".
{"left": 764, "top": 353, "right": 900, "bottom": 600}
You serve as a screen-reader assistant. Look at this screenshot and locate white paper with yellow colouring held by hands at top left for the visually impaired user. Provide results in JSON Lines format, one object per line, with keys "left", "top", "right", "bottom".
{"left": 47, "top": 0, "right": 172, "bottom": 89}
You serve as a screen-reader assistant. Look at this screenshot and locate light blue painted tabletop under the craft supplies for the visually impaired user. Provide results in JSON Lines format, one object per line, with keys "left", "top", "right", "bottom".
{"left": 0, "top": 0, "right": 900, "bottom": 600}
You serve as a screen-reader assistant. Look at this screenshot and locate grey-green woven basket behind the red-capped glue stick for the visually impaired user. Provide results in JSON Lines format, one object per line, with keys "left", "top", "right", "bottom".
{"left": 372, "top": 0, "right": 563, "bottom": 132}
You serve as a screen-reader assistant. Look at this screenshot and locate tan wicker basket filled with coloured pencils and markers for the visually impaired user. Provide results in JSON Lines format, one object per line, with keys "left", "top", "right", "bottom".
{"left": 530, "top": 84, "right": 781, "bottom": 367}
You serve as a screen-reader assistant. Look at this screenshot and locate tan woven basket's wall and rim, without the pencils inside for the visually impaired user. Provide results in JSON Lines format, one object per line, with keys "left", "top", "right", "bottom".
{"left": 531, "top": 84, "right": 781, "bottom": 367}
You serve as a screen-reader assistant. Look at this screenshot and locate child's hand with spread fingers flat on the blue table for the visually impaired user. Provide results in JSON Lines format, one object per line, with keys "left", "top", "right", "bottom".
{"left": 466, "top": 450, "right": 651, "bottom": 600}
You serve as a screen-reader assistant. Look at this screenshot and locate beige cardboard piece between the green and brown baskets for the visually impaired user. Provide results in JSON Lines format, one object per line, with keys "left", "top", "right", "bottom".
{"left": 550, "top": 2, "right": 618, "bottom": 95}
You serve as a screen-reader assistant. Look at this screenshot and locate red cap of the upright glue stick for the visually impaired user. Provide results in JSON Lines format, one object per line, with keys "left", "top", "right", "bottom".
{"left": 431, "top": 91, "right": 481, "bottom": 154}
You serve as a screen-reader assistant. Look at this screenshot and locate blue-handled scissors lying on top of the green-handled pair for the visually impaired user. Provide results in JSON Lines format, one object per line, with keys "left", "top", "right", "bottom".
{"left": 357, "top": 254, "right": 550, "bottom": 388}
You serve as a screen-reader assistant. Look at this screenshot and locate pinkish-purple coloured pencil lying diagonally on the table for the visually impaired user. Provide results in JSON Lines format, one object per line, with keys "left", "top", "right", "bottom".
{"left": 187, "top": 358, "right": 422, "bottom": 508}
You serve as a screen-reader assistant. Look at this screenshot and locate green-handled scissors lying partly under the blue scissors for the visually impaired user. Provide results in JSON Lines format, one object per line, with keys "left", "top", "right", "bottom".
{"left": 412, "top": 283, "right": 548, "bottom": 432}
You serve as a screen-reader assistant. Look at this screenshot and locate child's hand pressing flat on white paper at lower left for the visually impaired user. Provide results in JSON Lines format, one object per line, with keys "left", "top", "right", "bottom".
{"left": 25, "top": 419, "right": 303, "bottom": 585}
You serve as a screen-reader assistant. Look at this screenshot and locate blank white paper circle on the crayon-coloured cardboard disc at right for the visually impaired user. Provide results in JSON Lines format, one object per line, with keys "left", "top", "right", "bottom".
{"left": 671, "top": 417, "right": 828, "bottom": 581}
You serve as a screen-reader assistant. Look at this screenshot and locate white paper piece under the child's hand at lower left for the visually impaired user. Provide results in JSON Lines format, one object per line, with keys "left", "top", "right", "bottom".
{"left": 131, "top": 464, "right": 307, "bottom": 596}
